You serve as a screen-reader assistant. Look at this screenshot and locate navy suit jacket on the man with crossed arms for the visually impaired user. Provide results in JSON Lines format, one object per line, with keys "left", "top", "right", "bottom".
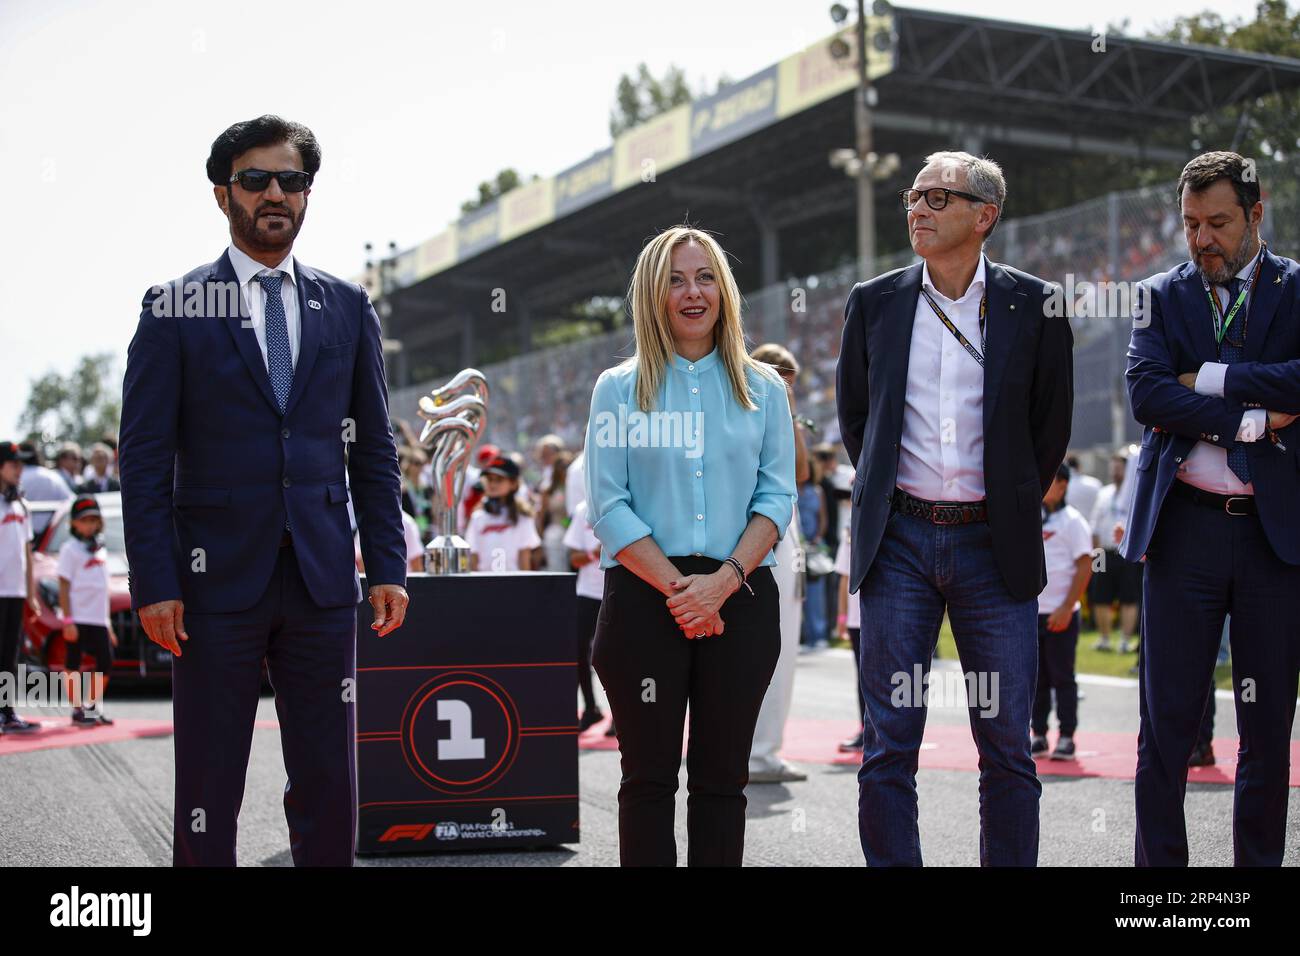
{"left": 1119, "top": 244, "right": 1300, "bottom": 564}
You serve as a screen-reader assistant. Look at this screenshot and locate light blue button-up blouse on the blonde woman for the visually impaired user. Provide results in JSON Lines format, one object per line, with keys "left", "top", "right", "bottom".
{"left": 585, "top": 347, "right": 796, "bottom": 568}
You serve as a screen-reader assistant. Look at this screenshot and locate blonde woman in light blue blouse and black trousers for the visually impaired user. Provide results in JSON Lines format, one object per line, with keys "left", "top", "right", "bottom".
{"left": 585, "top": 226, "right": 796, "bottom": 866}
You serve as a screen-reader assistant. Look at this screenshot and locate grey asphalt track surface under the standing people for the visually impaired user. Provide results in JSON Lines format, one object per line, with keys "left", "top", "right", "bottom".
{"left": 0, "top": 650, "right": 1300, "bottom": 866}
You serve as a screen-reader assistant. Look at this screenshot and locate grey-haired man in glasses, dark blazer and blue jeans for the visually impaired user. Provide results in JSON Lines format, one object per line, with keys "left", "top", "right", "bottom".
{"left": 836, "top": 152, "right": 1074, "bottom": 866}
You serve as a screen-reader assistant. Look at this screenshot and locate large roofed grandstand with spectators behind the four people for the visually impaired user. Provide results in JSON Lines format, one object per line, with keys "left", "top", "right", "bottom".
{"left": 364, "top": 8, "right": 1300, "bottom": 460}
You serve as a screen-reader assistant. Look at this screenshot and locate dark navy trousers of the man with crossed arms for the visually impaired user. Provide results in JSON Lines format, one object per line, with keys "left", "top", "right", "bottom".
{"left": 1134, "top": 493, "right": 1300, "bottom": 866}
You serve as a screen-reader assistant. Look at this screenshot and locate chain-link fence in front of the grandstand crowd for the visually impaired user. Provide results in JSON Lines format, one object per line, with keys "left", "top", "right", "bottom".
{"left": 390, "top": 163, "right": 1300, "bottom": 463}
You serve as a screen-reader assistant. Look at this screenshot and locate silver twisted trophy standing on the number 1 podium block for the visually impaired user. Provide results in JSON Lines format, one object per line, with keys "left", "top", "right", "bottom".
{"left": 419, "top": 368, "right": 488, "bottom": 575}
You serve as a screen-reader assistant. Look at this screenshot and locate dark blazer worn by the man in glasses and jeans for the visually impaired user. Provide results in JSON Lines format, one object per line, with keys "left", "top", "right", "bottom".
{"left": 836, "top": 260, "right": 1074, "bottom": 601}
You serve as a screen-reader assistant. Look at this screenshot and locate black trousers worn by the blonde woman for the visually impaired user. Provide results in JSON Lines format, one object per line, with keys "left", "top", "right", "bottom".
{"left": 592, "top": 557, "right": 781, "bottom": 866}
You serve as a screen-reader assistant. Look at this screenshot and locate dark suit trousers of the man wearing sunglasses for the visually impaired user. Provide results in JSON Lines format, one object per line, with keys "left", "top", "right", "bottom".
{"left": 172, "top": 548, "right": 358, "bottom": 866}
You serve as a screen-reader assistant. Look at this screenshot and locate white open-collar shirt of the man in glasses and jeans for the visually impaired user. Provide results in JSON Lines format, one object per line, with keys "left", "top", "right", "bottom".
{"left": 897, "top": 255, "right": 984, "bottom": 501}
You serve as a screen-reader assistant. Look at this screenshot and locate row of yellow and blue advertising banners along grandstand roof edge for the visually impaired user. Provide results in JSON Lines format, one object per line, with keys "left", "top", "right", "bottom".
{"left": 377, "top": 14, "right": 894, "bottom": 285}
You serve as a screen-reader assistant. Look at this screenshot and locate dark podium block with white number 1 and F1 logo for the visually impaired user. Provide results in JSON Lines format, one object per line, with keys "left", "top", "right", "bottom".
{"left": 356, "top": 571, "right": 579, "bottom": 853}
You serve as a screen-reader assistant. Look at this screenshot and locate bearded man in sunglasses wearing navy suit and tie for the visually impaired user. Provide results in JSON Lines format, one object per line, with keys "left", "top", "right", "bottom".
{"left": 120, "top": 116, "right": 407, "bottom": 866}
